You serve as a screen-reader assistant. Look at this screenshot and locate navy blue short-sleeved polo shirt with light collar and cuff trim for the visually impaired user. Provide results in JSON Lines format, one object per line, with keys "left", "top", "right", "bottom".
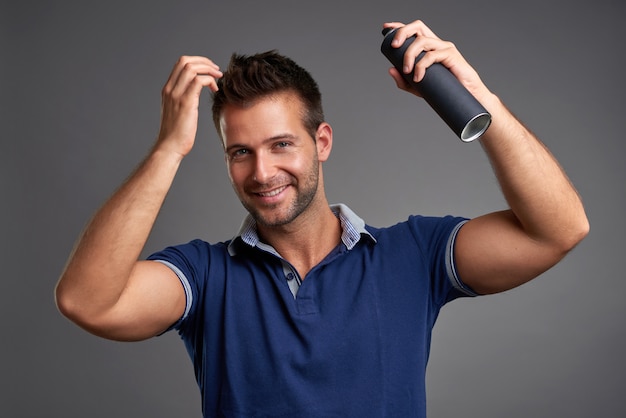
{"left": 149, "top": 205, "right": 475, "bottom": 418}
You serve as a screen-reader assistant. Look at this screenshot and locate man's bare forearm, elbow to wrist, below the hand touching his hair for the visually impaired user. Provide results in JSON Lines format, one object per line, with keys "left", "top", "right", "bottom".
{"left": 56, "top": 151, "right": 181, "bottom": 316}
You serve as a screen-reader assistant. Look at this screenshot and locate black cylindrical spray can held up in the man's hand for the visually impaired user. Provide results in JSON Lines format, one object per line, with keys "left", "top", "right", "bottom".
{"left": 380, "top": 28, "right": 491, "bottom": 142}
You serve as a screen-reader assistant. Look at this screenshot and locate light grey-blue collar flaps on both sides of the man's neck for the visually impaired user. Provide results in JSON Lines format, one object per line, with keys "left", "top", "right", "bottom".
{"left": 228, "top": 203, "right": 376, "bottom": 256}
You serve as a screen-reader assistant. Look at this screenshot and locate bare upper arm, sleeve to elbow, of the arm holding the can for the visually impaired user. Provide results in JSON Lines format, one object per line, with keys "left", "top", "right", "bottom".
{"left": 454, "top": 210, "right": 565, "bottom": 294}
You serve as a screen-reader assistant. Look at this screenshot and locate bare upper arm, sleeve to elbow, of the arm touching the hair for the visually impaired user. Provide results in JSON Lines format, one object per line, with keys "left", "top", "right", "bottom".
{"left": 89, "top": 261, "right": 186, "bottom": 341}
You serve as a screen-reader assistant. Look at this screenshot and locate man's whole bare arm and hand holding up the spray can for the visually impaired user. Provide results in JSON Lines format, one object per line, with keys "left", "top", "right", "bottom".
{"left": 385, "top": 21, "right": 589, "bottom": 294}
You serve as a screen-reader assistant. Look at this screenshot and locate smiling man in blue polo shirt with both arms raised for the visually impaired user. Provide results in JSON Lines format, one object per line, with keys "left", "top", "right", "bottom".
{"left": 56, "top": 21, "right": 588, "bottom": 417}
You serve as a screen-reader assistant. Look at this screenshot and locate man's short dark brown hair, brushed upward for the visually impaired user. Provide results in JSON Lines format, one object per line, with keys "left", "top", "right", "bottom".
{"left": 212, "top": 50, "right": 324, "bottom": 140}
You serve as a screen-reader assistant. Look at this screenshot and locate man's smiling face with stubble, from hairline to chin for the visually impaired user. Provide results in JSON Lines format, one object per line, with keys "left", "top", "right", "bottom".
{"left": 220, "top": 93, "right": 320, "bottom": 226}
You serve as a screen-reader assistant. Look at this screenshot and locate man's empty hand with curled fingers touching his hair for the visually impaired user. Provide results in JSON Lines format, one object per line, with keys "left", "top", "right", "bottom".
{"left": 156, "top": 56, "right": 222, "bottom": 157}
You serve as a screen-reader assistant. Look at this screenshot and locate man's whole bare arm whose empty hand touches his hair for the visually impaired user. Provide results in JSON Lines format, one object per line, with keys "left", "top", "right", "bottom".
{"left": 55, "top": 57, "right": 222, "bottom": 340}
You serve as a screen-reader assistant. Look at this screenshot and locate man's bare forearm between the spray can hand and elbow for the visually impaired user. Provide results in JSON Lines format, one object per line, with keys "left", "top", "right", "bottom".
{"left": 481, "top": 94, "right": 588, "bottom": 251}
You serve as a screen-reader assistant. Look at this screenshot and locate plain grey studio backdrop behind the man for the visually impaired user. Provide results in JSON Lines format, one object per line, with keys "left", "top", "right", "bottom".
{"left": 0, "top": 0, "right": 626, "bottom": 417}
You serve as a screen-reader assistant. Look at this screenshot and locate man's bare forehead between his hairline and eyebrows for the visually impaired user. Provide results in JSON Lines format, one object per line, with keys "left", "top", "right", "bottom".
{"left": 220, "top": 92, "right": 304, "bottom": 146}
